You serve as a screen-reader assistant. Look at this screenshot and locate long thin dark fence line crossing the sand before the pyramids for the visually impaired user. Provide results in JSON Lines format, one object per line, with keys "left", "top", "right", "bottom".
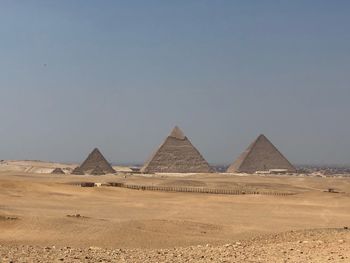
{"left": 108, "top": 183, "right": 295, "bottom": 196}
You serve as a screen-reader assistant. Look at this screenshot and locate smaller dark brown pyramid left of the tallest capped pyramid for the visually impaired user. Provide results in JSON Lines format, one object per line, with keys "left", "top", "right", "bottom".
{"left": 80, "top": 148, "right": 115, "bottom": 174}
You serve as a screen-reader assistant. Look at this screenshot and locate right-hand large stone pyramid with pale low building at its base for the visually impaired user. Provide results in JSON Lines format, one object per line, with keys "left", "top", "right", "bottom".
{"left": 227, "top": 134, "right": 296, "bottom": 173}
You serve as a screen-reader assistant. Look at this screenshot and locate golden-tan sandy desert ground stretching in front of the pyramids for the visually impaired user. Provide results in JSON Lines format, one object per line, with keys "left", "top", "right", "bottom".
{"left": 0, "top": 161, "right": 350, "bottom": 262}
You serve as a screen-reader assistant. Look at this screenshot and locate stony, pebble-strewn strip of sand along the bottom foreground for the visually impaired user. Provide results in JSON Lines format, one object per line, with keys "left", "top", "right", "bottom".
{"left": 0, "top": 229, "right": 350, "bottom": 263}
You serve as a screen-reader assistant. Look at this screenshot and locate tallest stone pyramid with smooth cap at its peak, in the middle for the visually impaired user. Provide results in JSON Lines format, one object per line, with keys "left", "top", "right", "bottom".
{"left": 141, "top": 127, "right": 212, "bottom": 173}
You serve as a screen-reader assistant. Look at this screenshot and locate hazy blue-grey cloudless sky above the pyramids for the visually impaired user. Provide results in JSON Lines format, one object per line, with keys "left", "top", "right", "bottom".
{"left": 0, "top": 0, "right": 350, "bottom": 164}
